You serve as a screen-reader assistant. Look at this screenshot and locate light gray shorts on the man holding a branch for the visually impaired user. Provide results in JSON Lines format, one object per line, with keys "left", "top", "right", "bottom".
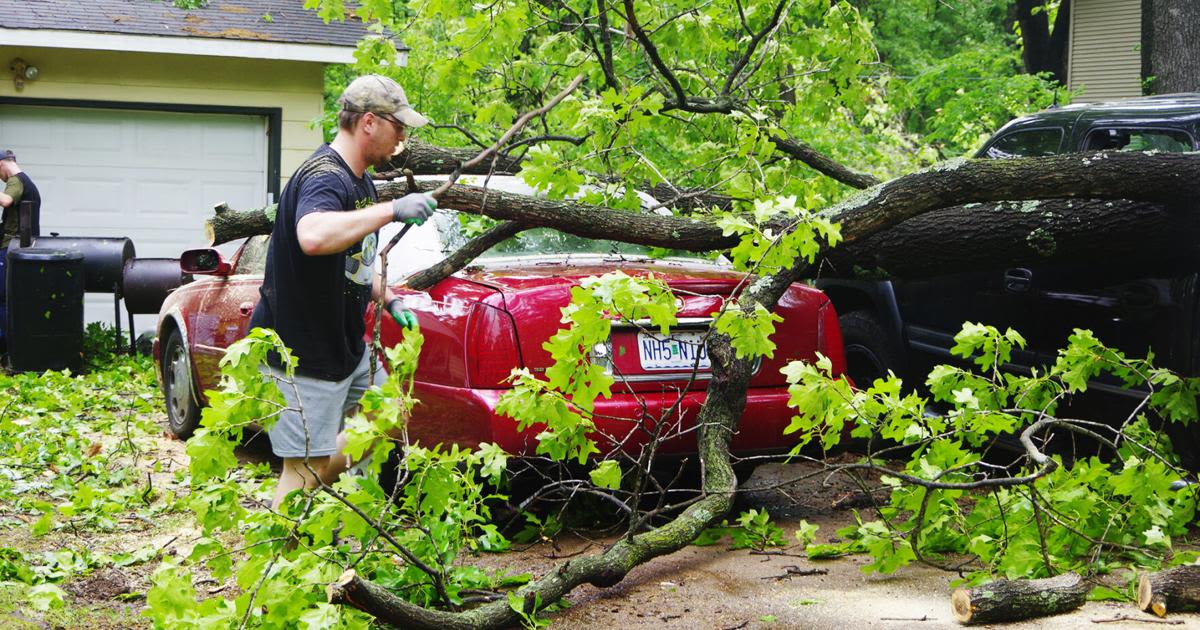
{"left": 263, "top": 344, "right": 383, "bottom": 457}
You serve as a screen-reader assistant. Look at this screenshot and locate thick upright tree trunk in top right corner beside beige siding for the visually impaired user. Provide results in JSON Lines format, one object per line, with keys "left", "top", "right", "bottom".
{"left": 1141, "top": 0, "right": 1200, "bottom": 94}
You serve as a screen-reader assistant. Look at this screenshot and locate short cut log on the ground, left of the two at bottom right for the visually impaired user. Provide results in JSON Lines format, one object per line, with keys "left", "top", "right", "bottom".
{"left": 950, "top": 574, "right": 1091, "bottom": 625}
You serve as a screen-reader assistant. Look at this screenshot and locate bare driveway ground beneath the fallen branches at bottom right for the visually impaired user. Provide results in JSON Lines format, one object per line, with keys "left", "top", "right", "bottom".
{"left": 472, "top": 464, "right": 1200, "bottom": 630}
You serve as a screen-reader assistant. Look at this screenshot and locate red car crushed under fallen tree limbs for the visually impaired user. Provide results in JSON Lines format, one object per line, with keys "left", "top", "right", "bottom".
{"left": 155, "top": 182, "right": 845, "bottom": 455}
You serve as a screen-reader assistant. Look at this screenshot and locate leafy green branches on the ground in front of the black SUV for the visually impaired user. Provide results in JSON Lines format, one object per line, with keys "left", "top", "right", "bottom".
{"left": 787, "top": 323, "right": 1200, "bottom": 581}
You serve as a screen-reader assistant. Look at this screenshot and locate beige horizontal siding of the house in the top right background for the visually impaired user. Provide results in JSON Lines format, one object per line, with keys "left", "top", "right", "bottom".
{"left": 1067, "top": 0, "right": 1141, "bottom": 102}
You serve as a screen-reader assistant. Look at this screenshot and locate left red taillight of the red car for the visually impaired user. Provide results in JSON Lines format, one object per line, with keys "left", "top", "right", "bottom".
{"left": 467, "top": 304, "right": 522, "bottom": 389}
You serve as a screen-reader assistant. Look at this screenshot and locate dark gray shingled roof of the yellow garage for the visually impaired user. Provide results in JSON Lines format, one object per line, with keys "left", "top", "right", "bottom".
{"left": 0, "top": 0, "right": 401, "bottom": 48}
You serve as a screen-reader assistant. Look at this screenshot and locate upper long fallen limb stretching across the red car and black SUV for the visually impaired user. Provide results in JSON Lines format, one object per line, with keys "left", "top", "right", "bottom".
{"left": 204, "top": 152, "right": 1200, "bottom": 276}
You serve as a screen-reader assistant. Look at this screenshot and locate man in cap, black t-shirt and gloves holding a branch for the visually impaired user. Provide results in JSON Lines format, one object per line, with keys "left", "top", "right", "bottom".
{"left": 250, "top": 74, "right": 437, "bottom": 506}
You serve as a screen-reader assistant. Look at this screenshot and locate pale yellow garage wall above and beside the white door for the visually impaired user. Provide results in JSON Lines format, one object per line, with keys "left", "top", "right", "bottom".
{"left": 0, "top": 46, "right": 324, "bottom": 188}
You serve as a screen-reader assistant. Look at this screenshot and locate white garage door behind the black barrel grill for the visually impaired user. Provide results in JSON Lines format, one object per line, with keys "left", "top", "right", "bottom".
{"left": 0, "top": 104, "right": 268, "bottom": 329}
